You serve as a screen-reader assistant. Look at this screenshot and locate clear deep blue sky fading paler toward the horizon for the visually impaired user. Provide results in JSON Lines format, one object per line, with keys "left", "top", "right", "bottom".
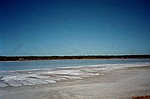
{"left": 0, "top": 0, "right": 150, "bottom": 56}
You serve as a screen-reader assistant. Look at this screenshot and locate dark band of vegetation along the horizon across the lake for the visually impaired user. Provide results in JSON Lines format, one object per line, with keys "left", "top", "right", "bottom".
{"left": 0, "top": 55, "right": 150, "bottom": 61}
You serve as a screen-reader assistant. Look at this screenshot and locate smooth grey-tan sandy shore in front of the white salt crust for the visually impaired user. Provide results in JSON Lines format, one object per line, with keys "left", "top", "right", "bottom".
{"left": 0, "top": 66, "right": 150, "bottom": 99}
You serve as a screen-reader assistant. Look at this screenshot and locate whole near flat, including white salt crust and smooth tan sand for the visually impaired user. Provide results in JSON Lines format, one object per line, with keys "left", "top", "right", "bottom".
{"left": 0, "top": 66, "right": 150, "bottom": 99}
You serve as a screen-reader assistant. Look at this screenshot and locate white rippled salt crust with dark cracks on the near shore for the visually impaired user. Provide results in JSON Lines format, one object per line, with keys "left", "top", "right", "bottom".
{"left": 0, "top": 67, "right": 111, "bottom": 87}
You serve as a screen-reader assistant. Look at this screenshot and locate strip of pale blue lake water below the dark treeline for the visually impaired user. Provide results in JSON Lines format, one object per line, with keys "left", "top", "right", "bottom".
{"left": 0, "top": 59, "right": 150, "bottom": 71}
